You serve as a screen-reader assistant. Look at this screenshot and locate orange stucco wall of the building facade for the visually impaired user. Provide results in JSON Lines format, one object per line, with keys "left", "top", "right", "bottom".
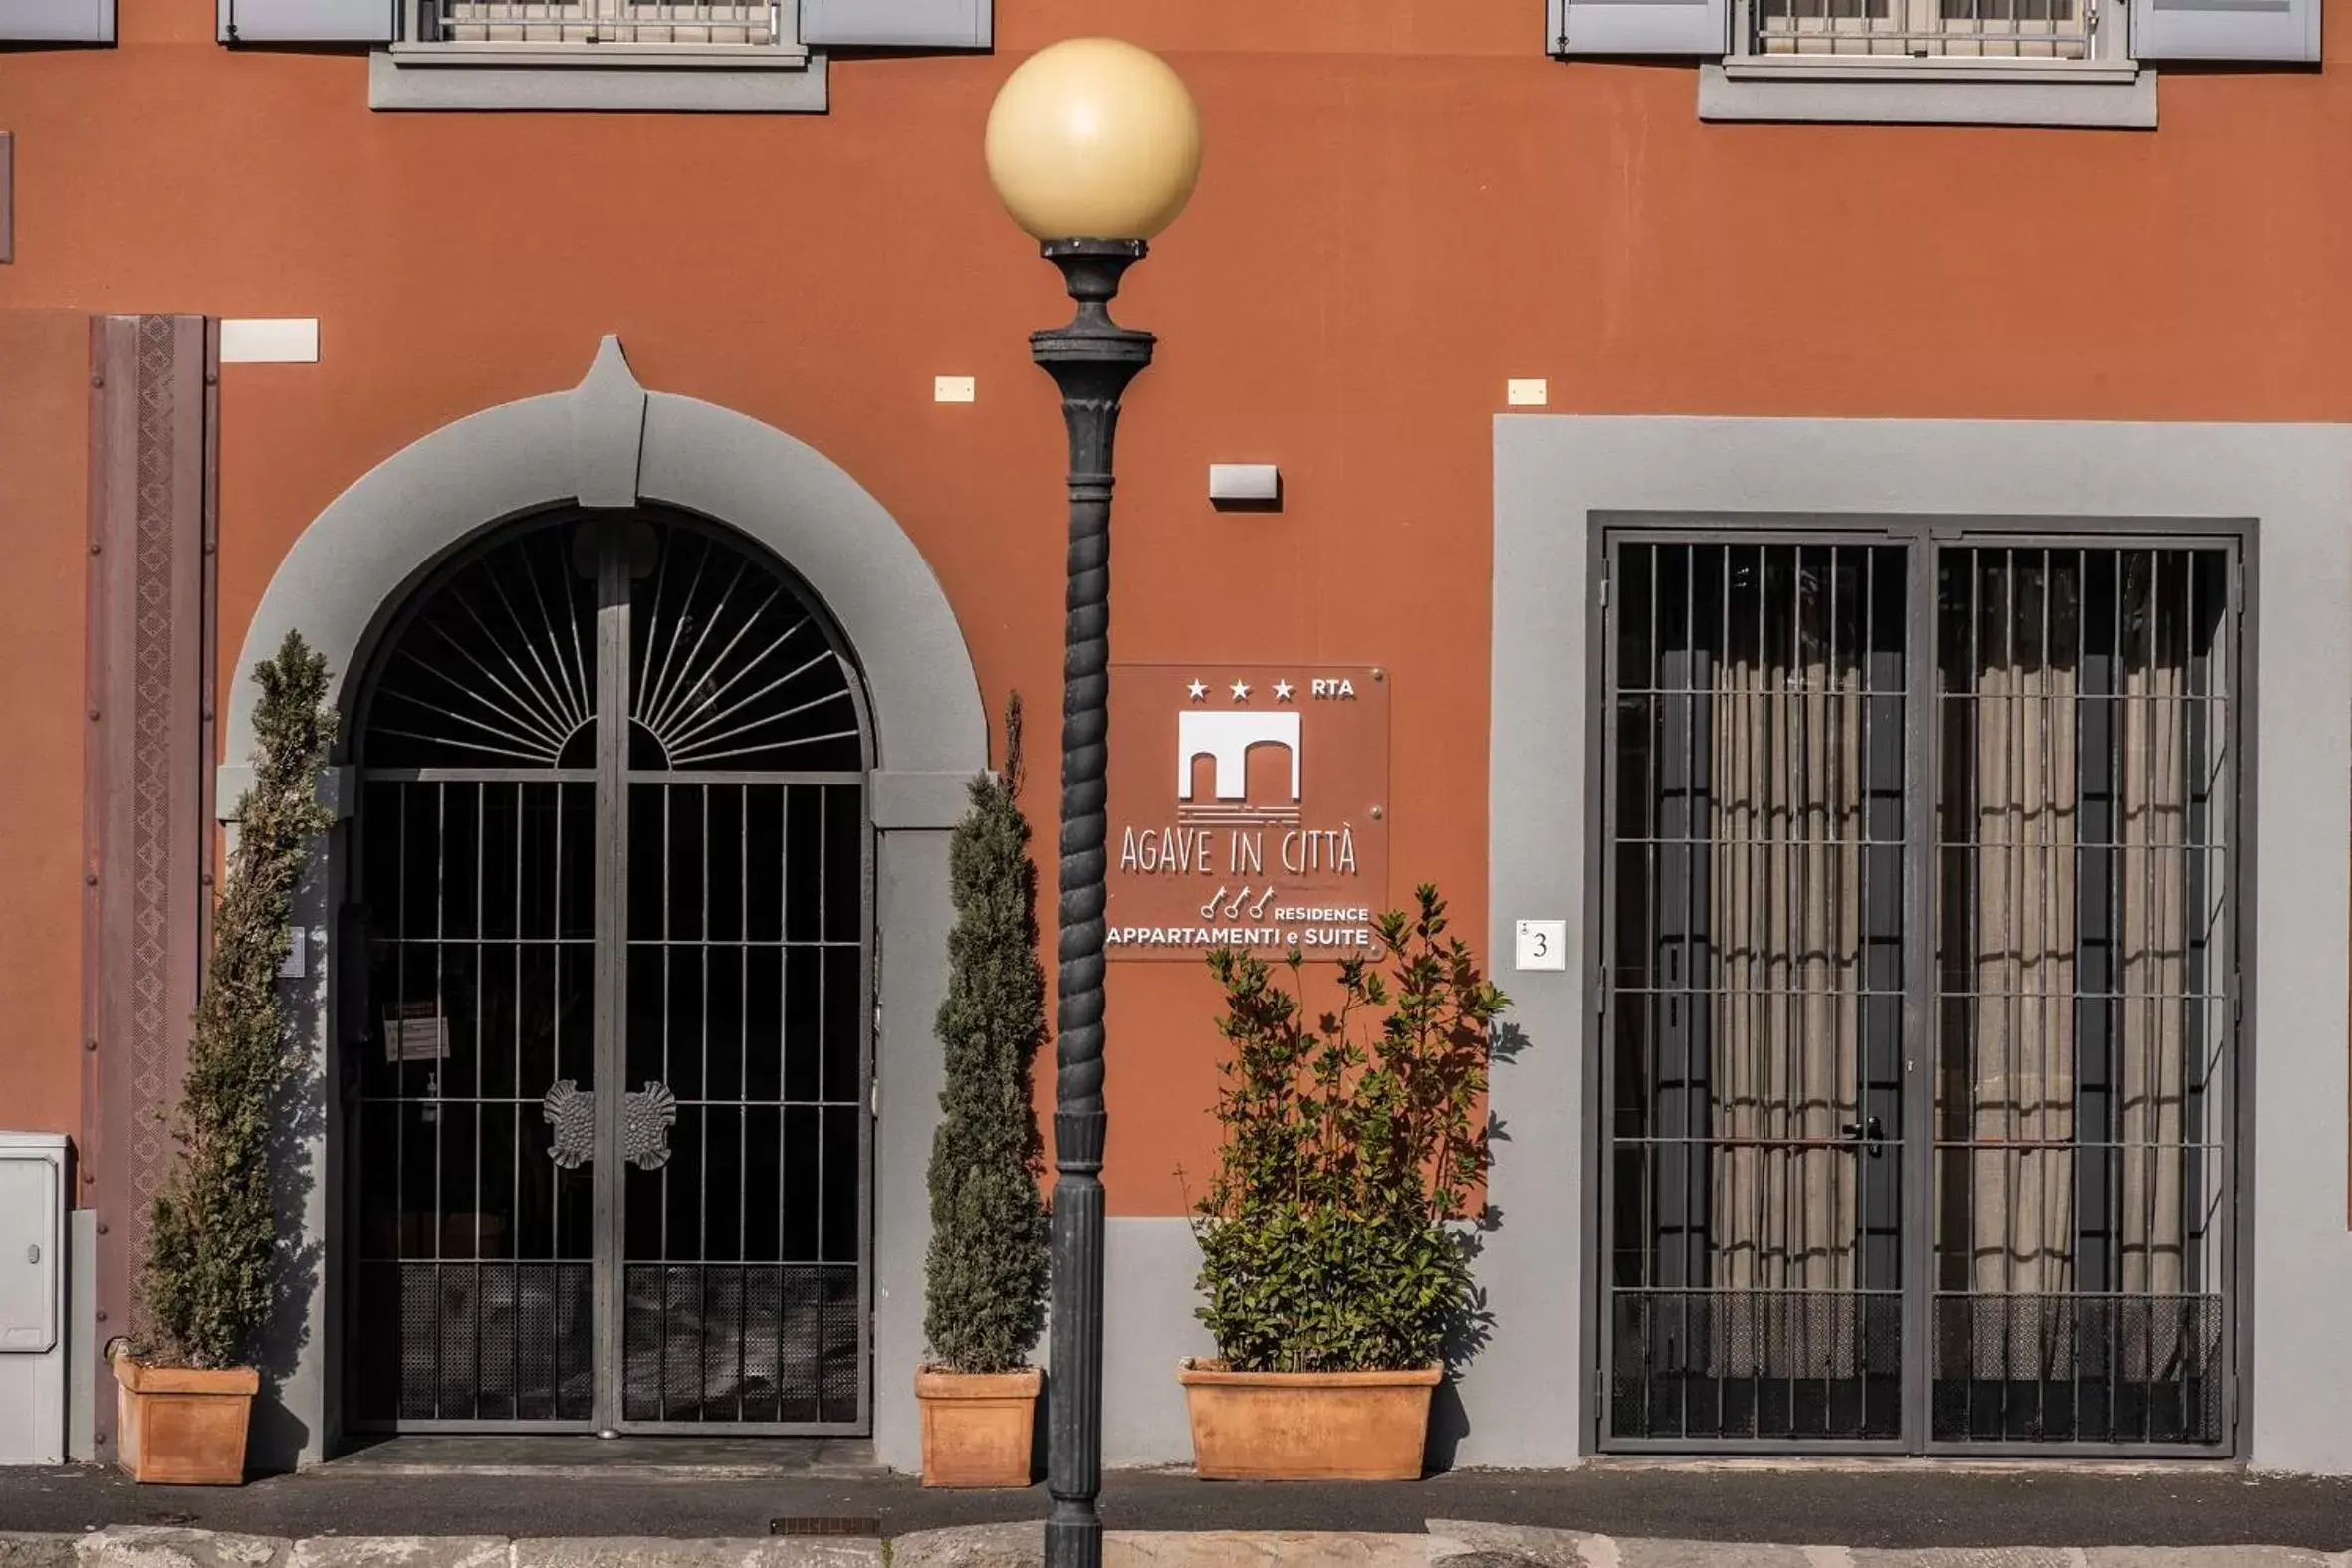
{"left": 0, "top": 0, "right": 2352, "bottom": 1213}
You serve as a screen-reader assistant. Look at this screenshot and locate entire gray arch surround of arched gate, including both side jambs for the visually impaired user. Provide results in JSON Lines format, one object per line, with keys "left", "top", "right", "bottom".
{"left": 219, "top": 338, "right": 988, "bottom": 1469}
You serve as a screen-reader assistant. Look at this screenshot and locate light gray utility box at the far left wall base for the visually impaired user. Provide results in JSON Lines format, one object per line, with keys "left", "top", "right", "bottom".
{"left": 0, "top": 1133, "right": 66, "bottom": 1464}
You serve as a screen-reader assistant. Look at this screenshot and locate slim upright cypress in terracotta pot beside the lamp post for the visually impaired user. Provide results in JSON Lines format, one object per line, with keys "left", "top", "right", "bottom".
{"left": 915, "top": 696, "right": 1047, "bottom": 1485}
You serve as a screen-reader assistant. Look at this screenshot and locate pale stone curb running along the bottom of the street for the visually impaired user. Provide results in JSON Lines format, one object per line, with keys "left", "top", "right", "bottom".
{"left": 0, "top": 1518, "right": 2352, "bottom": 1568}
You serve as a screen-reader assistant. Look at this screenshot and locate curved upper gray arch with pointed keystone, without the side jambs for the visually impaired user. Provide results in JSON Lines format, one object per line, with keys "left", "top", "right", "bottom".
{"left": 223, "top": 336, "right": 988, "bottom": 789}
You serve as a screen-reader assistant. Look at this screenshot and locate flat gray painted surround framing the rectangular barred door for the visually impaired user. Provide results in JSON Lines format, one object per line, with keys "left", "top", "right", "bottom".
{"left": 1461, "top": 416, "right": 2352, "bottom": 1474}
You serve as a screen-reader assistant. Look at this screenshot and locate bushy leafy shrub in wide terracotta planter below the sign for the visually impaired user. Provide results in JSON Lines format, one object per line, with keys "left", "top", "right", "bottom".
{"left": 1178, "top": 884, "right": 1506, "bottom": 1481}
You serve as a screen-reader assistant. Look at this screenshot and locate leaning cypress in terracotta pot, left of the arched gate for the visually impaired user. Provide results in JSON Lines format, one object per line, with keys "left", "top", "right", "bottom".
{"left": 113, "top": 632, "right": 334, "bottom": 1485}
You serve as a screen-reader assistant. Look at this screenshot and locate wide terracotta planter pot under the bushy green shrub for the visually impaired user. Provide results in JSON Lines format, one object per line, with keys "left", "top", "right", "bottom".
{"left": 1176, "top": 1361, "right": 1444, "bottom": 1481}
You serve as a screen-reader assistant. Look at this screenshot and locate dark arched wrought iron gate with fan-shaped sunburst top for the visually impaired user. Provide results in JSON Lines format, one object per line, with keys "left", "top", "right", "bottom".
{"left": 344, "top": 515, "right": 872, "bottom": 1432}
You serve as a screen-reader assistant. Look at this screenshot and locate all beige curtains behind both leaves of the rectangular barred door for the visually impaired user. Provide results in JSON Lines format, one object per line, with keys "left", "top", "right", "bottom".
{"left": 1705, "top": 551, "right": 2228, "bottom": 1378}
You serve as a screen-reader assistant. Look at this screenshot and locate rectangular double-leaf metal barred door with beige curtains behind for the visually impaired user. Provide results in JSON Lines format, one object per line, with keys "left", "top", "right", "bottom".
{"left": 1597, "top": 532, "right": 2239, "bottom": 1453}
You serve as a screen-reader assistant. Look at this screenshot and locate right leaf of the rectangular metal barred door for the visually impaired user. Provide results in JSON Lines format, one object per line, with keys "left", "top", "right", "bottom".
{"left": 1934, "top": 548, "right": 2225, "bottom": 1444}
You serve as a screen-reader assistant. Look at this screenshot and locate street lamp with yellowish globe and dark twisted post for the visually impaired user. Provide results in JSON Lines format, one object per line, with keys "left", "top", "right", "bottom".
{"left": 988, "top": 38, "right": 1200, "bottom": 1568}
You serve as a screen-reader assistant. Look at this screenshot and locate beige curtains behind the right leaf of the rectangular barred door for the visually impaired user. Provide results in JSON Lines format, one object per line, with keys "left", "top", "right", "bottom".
{"left": 1936, "top": 553, "right": 2225, "bottom": 1380}
